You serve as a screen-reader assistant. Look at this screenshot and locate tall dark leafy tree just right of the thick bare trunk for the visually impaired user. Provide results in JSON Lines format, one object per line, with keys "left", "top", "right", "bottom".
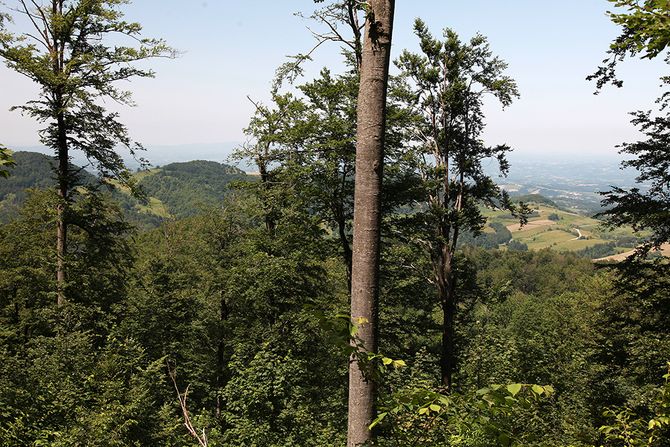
{"left": 396, "top": 19, "right": 523, "bottom": 389}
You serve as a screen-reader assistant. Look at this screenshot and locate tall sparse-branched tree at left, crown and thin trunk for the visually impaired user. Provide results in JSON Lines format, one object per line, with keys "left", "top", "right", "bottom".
{"left": 0, "top": 0, "right": 174, "bottom": 305}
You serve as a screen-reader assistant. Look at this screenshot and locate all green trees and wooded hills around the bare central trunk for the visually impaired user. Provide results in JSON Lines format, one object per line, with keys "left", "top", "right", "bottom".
{"left": 0, "top": 0, "right": 670, "bottom": 447}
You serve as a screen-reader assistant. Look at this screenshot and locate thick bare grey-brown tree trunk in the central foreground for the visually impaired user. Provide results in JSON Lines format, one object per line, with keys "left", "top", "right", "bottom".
{"left": 347, "top": 0, "right": 395, "bottom": 447}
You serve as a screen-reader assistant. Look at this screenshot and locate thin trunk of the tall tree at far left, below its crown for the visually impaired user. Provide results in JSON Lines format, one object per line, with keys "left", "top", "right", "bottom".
{"left": 56, "top": 108, "right": 70, "bottom": 306}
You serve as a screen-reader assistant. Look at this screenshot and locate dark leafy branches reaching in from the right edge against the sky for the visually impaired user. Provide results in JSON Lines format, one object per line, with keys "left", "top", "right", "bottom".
{"left": 588, "top": 0, "right": 670, "bottom": 291}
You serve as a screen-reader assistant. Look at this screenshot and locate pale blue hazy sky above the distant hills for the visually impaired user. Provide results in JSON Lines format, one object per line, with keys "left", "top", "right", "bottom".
{"left": 0, "top": 0, "right": 664, "bottom": 158}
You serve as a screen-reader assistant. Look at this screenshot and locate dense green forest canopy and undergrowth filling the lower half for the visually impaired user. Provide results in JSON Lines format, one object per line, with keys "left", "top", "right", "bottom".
{"left": 0, "top": 192, "right": 670, "bottom": 446}
